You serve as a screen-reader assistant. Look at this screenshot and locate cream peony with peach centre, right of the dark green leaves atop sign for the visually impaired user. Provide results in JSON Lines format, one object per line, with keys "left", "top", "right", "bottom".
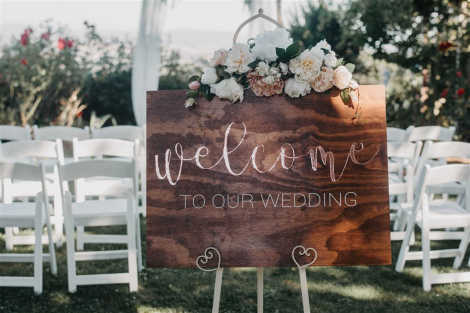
{"left": 289, "top": 47, "right": 323, "bottom": 83}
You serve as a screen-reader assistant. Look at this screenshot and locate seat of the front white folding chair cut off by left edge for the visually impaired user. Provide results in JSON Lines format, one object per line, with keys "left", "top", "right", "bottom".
{"left": 0, "top": 202, "right": 45, "bottom": 227}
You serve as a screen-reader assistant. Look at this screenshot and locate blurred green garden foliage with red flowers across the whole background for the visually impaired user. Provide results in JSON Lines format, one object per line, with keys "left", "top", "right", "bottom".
{"left": 0, "top": 0, "right": 470, "bottom": 141}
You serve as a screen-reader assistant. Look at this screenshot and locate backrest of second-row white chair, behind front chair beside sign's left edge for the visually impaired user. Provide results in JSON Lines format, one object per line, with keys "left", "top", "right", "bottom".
{"left": 73, "top": 138, "right": 138, "bottom": 161}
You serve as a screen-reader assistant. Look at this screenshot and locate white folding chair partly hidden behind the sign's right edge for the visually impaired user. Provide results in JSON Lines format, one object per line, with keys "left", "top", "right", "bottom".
{"left": 387, "top": 142, "right": 421, "bottom": 240}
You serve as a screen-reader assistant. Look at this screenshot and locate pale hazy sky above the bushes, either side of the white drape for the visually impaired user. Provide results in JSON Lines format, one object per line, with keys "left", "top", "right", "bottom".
{"left": 0, "top": 0, "right": 307, "bottom": 57}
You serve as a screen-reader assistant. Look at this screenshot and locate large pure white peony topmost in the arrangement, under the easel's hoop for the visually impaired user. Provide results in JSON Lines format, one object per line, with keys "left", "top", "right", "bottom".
{"left": 253, "top": 28, "right": 292, "bottom": 62}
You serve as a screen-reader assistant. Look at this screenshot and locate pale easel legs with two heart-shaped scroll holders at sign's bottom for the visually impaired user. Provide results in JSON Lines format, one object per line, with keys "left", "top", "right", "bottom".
{"left": 196, "top": 245, "right": 318, "bottom": 313}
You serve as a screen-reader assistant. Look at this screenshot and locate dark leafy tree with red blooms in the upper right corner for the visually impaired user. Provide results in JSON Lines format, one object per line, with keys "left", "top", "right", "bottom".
{"left": 346, "top": 0, "right": 470, "bottom": 140}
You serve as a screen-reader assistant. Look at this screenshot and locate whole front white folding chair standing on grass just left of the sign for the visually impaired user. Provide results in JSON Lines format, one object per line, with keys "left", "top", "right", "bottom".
{"left": 59, "top": 160, "right": 138, "bottom": 293}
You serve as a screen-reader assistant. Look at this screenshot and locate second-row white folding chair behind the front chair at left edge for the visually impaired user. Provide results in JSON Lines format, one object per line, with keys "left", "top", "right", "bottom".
{"left": 0, "top": 140, "right": 64, "bottom": 250}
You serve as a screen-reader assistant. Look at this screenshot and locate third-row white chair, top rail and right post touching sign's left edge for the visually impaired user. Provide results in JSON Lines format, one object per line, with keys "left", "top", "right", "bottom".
{"left": 91, "top": 125, "right": 147, "bottom": 217}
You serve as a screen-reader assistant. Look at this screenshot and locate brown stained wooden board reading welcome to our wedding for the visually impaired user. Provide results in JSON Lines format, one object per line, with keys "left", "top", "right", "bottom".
{"left": 147, "top": 86, "right": 391, "bottom": 267}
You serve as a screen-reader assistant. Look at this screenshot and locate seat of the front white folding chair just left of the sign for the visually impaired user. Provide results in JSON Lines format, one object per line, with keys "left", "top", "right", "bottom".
{"left": 72, "top": 199, "right": 128, "bottom": 226}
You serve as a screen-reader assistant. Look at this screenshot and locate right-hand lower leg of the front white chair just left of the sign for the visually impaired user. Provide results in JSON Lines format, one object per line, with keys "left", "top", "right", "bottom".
{"left": 127, "top": 200, "right": 139, "bottom": 292}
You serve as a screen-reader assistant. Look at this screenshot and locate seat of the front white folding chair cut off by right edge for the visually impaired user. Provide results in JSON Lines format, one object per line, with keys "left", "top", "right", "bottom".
{"left": 418, "top": 200, "right": 470, "bottom": 228}
